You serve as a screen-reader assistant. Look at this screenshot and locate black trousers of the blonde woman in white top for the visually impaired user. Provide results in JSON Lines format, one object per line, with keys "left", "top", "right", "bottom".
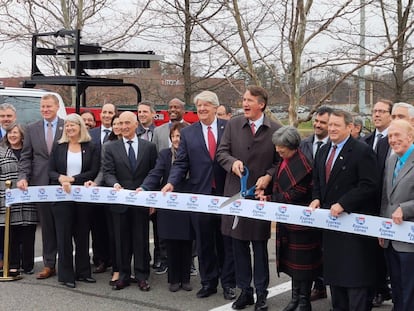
{"left": 52, "top": 202, "right": 91, "bottom": 282}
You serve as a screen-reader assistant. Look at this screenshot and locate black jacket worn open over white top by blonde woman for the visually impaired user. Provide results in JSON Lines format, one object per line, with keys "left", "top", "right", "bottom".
{"left": 49, "top": 142, "right": 99, "bottom": 185}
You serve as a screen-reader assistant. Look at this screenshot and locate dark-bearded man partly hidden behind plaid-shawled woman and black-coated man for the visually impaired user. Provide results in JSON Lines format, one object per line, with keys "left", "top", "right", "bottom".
{"left": 299, "top": 106, "right": 332, "bottom": 161}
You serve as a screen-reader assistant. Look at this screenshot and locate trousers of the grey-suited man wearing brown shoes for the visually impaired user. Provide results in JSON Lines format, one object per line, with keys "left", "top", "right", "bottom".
{"left": 36, "top": 203, "right": 57, "bottom": 268}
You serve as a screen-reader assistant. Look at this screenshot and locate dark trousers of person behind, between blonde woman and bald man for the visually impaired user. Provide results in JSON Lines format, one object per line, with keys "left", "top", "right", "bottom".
{"left": 90, "top": 204, "right": 110, "bottom": 266}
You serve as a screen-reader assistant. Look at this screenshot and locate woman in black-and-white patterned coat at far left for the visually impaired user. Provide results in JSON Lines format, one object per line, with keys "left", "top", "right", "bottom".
{"left": 0, "top": 123, "right": 38, "bottom": 274}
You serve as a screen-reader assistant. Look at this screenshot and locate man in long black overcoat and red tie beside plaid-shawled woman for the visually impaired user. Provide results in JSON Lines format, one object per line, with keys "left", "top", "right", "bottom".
{"left": 310, "top": 110, "right": 379, "bottom": 311}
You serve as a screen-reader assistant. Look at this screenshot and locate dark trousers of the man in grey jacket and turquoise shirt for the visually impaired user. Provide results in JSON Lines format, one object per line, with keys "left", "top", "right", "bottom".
{"left": 385, "top": 244, "right": 414, "bottom": 311}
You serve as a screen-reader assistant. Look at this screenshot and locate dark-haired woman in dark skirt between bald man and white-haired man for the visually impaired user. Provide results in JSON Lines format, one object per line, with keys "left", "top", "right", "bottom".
{"left": 138, "top": 122, "right": 194, "bottom": 292}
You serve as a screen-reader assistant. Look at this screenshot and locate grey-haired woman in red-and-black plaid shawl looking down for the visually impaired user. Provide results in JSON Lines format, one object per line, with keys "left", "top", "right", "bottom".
{"left": 261, "top": 126, "right": 322, "bottom": 311}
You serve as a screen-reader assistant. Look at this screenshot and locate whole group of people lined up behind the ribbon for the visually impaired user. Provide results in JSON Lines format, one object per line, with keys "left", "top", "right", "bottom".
{"left": 0, "top": 86, "right": 414, "bottom": 311}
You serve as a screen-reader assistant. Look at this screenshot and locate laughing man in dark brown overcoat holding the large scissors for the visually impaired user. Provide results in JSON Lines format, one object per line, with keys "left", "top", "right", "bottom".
{"left": 217, "top": 86, "right": 280, "bottom": 310}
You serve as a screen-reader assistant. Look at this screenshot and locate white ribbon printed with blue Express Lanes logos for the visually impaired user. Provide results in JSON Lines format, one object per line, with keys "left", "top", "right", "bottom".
{"left": 6, "top": 186, "right": 414, "bottom": 243}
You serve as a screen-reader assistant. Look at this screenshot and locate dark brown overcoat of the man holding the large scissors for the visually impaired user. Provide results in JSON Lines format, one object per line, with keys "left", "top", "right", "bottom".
{"left": 217, "top": 116, "right": 280, "bottom": 241}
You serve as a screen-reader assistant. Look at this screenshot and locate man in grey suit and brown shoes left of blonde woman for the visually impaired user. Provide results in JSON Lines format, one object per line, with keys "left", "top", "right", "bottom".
{"left": 17, "top": 94, "right": 64, "bottom": 279}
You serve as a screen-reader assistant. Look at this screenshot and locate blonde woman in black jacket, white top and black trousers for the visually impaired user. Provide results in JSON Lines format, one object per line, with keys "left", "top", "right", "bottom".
{"left": 49, "top": 113, "right": 99, "bottom": 288}
